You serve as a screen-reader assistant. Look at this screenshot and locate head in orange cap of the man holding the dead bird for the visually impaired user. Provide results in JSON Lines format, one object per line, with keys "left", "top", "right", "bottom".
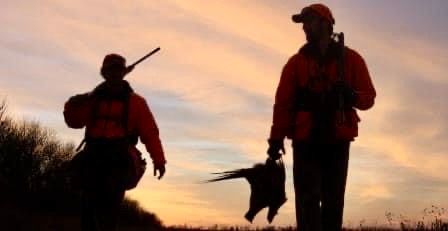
{"left": 292, "top": 4, "right": 335, "bottom": 43}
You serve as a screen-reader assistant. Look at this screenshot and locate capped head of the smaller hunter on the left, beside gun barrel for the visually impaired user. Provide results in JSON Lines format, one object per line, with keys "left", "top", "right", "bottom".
{"left": 101, "top": 54, "right": 127, "bottom": 81}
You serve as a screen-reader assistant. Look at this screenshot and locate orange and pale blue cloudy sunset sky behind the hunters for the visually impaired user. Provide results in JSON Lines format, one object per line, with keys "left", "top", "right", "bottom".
{"left": 0, "top": 0, "right": 448, "bottom": 226}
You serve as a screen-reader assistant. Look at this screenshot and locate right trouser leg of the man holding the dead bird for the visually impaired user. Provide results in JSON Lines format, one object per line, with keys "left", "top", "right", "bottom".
{"left": 322, "top": 142, "right": 350, "bottom": 231}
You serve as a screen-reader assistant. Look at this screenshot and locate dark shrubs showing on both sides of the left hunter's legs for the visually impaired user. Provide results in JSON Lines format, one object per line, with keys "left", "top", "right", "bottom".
{"left": 0, "top": 101, "right": 162, "bottom": 230}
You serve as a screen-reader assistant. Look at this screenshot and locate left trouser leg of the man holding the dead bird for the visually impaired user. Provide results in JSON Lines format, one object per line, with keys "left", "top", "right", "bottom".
{"left": 293, "top": 142, "right": 321, "bottom": 231}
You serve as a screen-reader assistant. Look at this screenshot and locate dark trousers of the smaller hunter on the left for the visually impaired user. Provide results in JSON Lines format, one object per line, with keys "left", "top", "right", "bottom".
{"left": 81, "top": 143, "right": 128, "bottom": 231}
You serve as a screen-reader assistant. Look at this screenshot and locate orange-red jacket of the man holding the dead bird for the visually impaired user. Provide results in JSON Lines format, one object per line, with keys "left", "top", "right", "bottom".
{"left": 270, "top": 43, "right": 376, "bottom": 141}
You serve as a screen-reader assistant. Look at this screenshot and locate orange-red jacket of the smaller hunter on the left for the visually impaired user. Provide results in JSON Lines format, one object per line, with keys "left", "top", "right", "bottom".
{"left": 64, "top": 82, "right": 166, "bottom": 165}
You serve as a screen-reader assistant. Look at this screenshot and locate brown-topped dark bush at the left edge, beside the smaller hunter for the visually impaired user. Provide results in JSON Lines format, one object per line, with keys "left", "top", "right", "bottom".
{"left": 0, "top": 102, "right": 74, "bottom": 206}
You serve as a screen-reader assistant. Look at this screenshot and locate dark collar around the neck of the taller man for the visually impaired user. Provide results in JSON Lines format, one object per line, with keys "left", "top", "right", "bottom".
{"left": 299, "top": 41, "right": 339, "bottom": 64}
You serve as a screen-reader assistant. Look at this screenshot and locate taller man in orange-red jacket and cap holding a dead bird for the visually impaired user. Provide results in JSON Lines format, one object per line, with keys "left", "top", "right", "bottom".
{"left": 267, "top": 4, "right": 376, "bottom": 231}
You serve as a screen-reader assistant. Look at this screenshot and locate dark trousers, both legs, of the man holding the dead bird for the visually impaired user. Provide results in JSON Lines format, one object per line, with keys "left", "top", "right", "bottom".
{"left": 293, "top": 141, "right": 350, "bottom": 231}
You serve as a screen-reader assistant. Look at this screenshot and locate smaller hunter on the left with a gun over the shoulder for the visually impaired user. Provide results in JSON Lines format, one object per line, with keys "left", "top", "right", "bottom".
{"left": 64, "top": 54, "right": 166, "bottom": 231}
